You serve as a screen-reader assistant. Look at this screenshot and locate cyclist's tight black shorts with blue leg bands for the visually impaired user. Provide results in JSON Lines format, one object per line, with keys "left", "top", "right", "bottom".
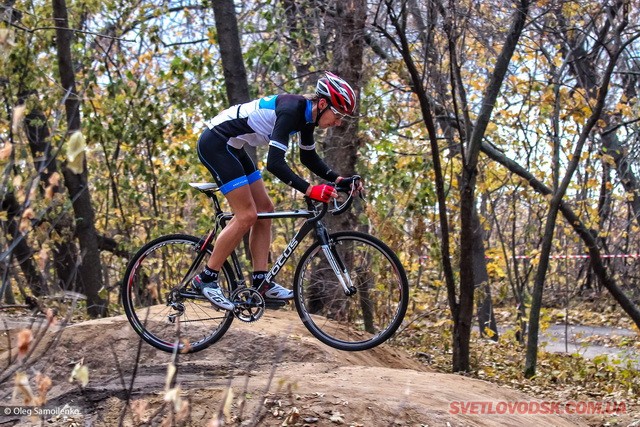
{"left": 198, "top": 129, "right": 262, "bottom": 194}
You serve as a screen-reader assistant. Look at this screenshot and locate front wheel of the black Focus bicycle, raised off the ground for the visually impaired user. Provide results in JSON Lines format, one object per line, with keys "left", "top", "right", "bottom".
{"left": 294, "top": 231, "right": 409, "bottom": 351}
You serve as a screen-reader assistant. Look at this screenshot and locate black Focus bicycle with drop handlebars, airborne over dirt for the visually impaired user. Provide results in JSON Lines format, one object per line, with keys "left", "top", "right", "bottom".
{"left": 121, "top": 176, "right": 409, "bottom": 353}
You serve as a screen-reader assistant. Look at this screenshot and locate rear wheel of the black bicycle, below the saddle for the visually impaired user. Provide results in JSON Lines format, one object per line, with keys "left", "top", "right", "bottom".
{"left": 121, "top": 234, "right": 236, "bottom": 353}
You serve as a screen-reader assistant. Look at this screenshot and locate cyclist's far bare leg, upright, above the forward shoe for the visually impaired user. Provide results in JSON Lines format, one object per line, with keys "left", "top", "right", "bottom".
{"left": 249, "top": 179, "right": 273, "bottom": 271}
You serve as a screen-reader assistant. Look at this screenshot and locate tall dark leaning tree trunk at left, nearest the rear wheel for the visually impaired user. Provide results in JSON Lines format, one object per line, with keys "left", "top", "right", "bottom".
{"left": 53, "top": 0, "right": 106, "bottom": 317}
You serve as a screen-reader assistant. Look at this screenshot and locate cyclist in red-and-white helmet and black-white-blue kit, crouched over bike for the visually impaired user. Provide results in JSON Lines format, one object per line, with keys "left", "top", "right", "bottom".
{"left": 192, "top": 72, "right": 361, "bottom": 310}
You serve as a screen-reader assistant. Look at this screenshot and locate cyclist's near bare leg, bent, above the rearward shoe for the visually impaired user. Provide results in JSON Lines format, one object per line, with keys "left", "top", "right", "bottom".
{"left": 207, "top": 185, "right": 258, "bottom": 271}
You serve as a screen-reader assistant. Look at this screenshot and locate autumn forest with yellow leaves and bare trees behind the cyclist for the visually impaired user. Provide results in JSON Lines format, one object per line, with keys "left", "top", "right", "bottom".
{"left": 0, "top": 0, "right": 640, "bottom": 412}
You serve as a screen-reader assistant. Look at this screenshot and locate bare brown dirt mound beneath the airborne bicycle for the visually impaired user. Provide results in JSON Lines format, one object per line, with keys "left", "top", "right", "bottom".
{"left": 0, "top": 311, "right": 583, "bottom": 426}
